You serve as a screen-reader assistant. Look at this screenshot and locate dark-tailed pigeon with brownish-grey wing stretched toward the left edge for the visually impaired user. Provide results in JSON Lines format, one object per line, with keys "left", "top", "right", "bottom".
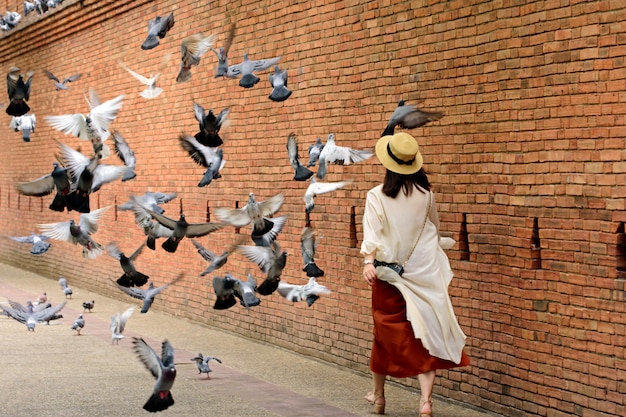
{"left": 17, "top": 162, "right": 75, "bottom": 211}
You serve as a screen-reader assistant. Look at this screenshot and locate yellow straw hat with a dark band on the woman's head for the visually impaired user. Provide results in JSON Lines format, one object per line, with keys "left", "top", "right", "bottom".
{"left": 376, "top": 132, "right": 424, "bottom": 175}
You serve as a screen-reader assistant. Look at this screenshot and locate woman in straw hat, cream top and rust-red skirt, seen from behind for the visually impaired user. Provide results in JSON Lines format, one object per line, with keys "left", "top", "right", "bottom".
{"left": 361, "top": 132, "right": 469, "bottom": 416}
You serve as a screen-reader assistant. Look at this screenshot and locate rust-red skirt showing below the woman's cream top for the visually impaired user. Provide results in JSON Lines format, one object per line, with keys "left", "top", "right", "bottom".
{"left": 370, "top": 280, "right": 470, "bottom": 378}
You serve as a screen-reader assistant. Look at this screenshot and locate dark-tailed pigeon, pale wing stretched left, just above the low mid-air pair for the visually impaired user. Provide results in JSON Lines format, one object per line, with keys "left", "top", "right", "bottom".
{"left": 237, "top": 241, "right": 287, "bottom": 295}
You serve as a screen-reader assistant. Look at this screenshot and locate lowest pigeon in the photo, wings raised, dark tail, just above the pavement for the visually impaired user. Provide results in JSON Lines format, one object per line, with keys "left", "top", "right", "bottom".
{"left": 133, "top": 337, "right": 176, "bottom": 413}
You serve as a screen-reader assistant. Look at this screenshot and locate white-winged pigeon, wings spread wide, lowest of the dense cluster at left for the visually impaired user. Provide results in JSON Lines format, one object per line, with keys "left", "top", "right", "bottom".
{"left": 39, "top": 206, "right": 110, "bottom": 259}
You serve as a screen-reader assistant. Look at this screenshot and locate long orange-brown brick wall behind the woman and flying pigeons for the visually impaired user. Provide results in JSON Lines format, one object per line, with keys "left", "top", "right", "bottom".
{"left": 0, "top": 0, "right": 626, "bottom": 416}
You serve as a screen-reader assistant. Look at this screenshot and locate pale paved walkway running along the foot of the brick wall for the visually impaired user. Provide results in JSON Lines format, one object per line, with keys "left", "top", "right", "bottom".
{"left": 0, "top": 264, "right": 496, "bottom": 417}
